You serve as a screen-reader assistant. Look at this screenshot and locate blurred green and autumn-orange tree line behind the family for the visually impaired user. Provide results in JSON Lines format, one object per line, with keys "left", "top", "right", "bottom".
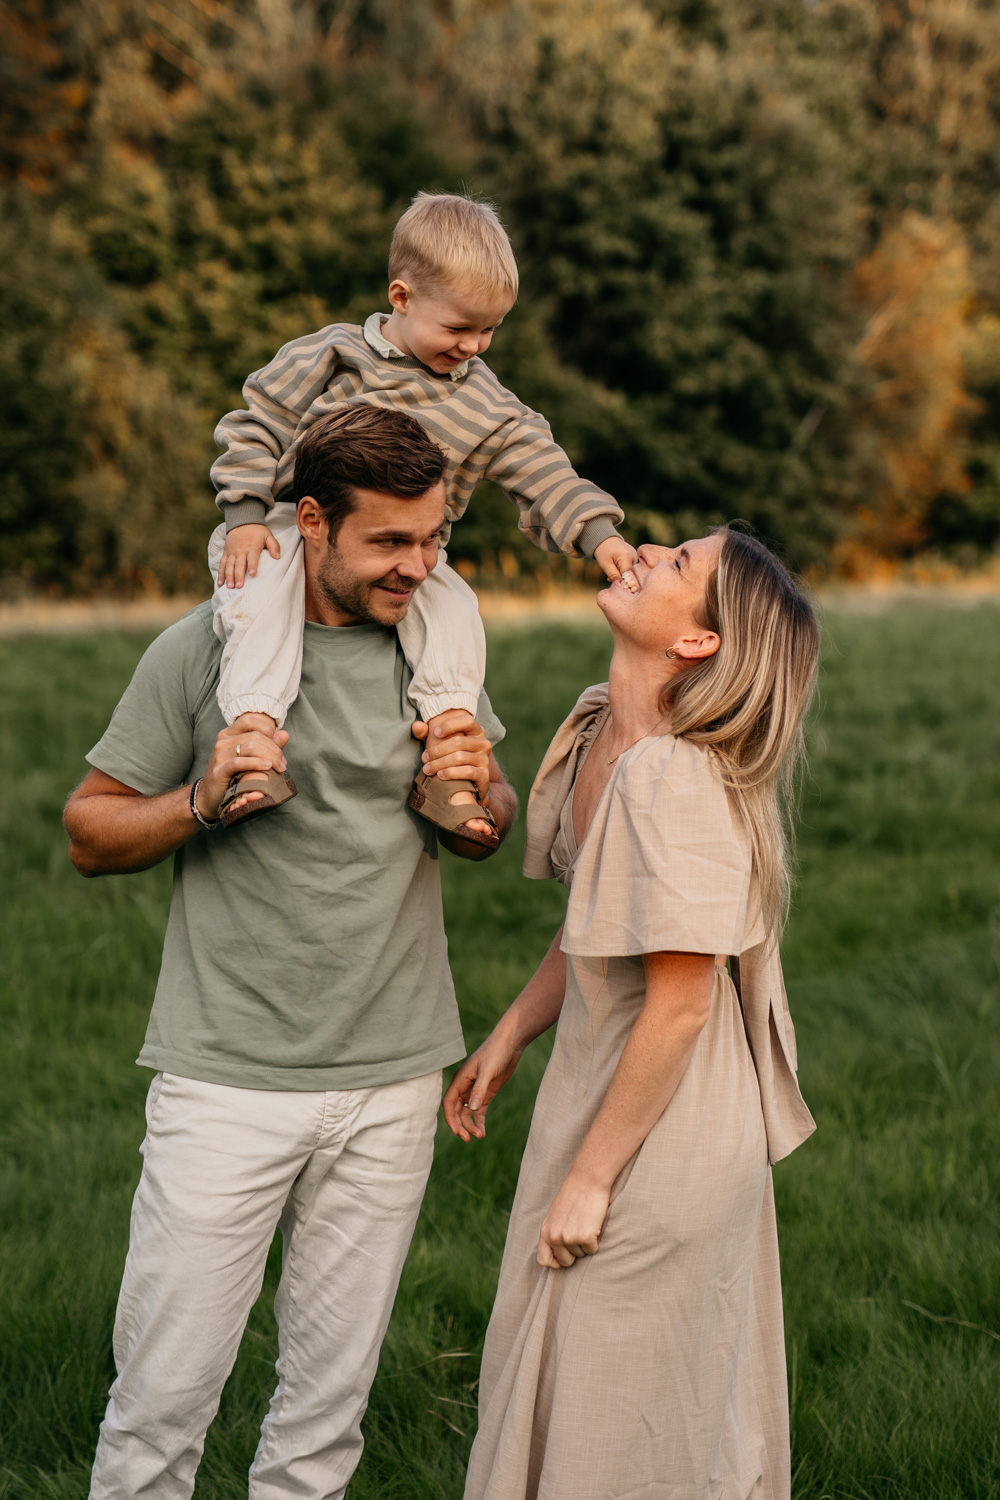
{"left": 0, "top": 0, "right": 1000, "bottom": 594}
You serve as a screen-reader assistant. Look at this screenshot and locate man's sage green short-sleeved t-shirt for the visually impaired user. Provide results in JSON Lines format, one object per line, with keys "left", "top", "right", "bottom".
{"left": 87, "top": 605, "right": 504, "bottom": 1089}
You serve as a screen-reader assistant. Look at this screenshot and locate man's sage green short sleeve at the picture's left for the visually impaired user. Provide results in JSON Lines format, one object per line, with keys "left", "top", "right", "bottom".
{"left": 87, "top": 609, "right": 219, "bottom": 797}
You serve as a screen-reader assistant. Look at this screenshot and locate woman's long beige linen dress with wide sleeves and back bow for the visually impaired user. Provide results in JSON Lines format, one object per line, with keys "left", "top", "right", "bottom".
{"left": 465, "top": 687, "right": 814, "bottom": 1500}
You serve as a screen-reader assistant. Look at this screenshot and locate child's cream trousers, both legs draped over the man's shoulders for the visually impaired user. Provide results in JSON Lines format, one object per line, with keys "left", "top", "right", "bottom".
{"left": 208, "top": 503, "right": 486, "bottom": 725}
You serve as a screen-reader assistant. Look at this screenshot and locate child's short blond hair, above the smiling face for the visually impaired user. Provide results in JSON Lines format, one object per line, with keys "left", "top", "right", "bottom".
{"left": 388, "top": 192, "right": 517, "bottom": 306}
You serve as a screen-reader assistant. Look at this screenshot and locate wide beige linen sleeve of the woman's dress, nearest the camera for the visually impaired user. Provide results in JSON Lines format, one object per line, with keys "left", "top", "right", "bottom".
{"left": 562, "top": 735, "right": 751, "bottom": 959}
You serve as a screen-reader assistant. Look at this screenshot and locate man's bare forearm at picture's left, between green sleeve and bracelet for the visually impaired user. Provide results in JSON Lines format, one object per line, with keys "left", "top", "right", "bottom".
{"left": 64, "top": 786, "right": 199, "bottom": 876}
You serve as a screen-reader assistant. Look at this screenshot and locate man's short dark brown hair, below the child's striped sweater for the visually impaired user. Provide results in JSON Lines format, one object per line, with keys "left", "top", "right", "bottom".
{"left": 292, "top": 405, "right": 445, "bottom": 542}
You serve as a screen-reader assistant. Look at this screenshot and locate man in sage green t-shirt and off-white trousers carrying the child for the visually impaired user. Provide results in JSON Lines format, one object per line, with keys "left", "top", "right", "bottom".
{"left": 66, "top": 407, "right": 516, "bottom": 1500}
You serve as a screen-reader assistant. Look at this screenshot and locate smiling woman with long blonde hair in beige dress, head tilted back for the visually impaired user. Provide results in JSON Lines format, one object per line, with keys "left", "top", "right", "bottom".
{"left": 445, "top": 530, "right": 819, "bottom": 1500}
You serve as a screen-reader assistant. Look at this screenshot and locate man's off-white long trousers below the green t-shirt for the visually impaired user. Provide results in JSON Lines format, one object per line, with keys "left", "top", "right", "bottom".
{"left": 90, "top": 1073, "right": 441, "bottom": 1500}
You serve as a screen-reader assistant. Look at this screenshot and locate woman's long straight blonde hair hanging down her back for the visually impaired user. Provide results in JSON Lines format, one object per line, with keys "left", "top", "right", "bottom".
{"left": 664, "top": 527, "right": 820, "bottom": 938}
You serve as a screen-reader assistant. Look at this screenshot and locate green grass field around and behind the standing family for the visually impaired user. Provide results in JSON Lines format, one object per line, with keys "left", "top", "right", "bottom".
{"left": 0, "top": 606, "right": 1000, "bottom": 1500}
